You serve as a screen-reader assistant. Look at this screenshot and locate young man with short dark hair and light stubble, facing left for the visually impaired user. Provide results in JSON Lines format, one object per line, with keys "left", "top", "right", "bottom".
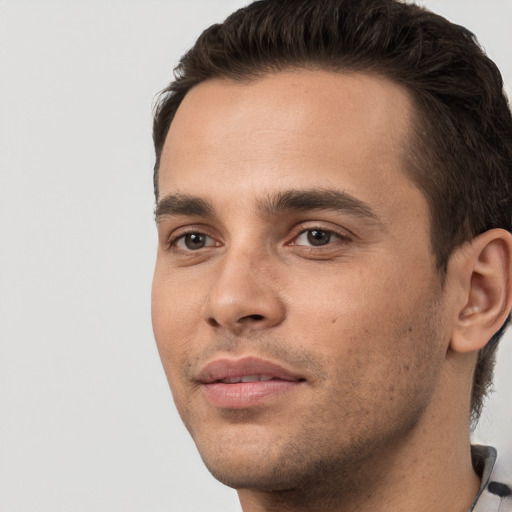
{"left": 152, "top": 0, "right": 512, "bottom": 512}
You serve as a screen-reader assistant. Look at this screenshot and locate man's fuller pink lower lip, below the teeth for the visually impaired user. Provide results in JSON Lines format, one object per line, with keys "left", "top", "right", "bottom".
{"left": 204, "top": 380, "right": 301, "bottom": 409}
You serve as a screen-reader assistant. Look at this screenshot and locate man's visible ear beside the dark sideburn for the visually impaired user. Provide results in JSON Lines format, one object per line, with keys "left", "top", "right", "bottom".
{"left": 447, "top": 229, "right": 512, "bottom": 353}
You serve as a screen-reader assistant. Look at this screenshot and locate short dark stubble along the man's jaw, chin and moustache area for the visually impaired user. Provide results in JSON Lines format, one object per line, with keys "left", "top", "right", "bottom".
{"left": 181, "top": 303, "right": 448, "bottom": 505}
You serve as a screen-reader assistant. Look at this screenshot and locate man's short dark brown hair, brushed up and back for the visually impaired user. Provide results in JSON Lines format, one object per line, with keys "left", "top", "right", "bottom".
{"left": 153, "top": 0, "right": 512, "bottom": 421}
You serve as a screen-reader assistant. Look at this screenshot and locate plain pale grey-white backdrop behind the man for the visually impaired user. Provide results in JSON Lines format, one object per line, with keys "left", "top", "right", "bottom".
{"left": 0, "top": 0, "right": 512, "bottom": 512}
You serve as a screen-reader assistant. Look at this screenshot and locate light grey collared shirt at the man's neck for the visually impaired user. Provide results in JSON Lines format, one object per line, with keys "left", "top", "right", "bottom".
{"left": 469, "top": 445, "right": 512, "bottom": 512}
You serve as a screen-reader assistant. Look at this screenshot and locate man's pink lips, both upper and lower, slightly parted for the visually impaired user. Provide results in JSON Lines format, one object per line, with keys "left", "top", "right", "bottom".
{"left": 197, "top": 357, "right": 306, "bottom": 409}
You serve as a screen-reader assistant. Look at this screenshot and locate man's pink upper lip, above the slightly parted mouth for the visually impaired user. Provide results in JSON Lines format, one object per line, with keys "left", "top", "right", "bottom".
{"left": 197, "top": 357, "right": 305, "bottom": 384}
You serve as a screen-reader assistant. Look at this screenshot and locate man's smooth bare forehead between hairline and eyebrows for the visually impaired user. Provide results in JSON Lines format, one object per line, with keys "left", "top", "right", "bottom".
{"left": 159, "top": 70, "right": 417, "bottom": 220}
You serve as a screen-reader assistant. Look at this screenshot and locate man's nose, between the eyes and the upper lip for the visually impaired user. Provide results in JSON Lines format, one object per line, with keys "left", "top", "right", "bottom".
{"left": 204, "top": 247, "right": 286, "bottom": 334}
